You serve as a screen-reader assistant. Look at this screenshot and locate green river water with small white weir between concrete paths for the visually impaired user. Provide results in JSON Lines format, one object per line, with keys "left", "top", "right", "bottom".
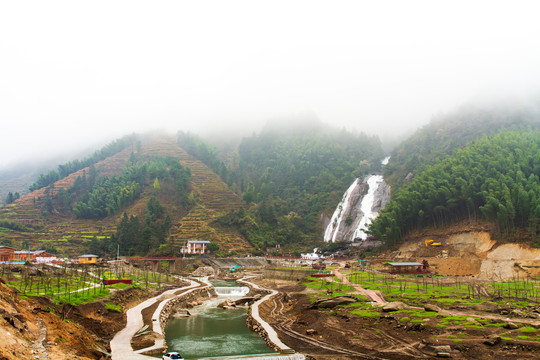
{"left": 165, "top": 282, "right": 273, "bottom": 359}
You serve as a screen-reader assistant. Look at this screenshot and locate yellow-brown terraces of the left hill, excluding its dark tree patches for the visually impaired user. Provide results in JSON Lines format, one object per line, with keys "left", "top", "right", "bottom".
{"left": 0, "top": 138, "right": 251, "bottom": 256}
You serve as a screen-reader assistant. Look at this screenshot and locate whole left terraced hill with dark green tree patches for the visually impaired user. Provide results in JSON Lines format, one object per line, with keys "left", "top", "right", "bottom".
{"left": 0, "top": 138, "right": 250, "bottom": 255}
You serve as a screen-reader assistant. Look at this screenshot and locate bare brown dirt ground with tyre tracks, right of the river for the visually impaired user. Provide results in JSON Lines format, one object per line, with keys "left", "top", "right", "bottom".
{"left": 258, "top": 280, "right": 540, "bottom": 360}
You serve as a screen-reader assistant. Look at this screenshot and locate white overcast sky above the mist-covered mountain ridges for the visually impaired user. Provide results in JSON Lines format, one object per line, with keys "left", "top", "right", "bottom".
{"left": 0, "top": 0, "right": 540, "bottom": 167}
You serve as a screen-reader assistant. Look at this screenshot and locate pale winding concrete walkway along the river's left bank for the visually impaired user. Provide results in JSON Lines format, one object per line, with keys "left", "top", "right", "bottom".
{"left": 111, "top": 280, "right": 200, "bottom": 360}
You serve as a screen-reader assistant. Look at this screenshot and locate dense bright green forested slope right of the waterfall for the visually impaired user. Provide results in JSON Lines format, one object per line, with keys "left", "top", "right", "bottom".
{"left": 371, "top": 130, "right": 540, "bottom": 246}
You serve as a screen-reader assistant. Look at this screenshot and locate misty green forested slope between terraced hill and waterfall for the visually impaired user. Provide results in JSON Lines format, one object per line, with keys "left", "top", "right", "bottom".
{"left": 184, "top": 119, "right": 384, "bottom": 252}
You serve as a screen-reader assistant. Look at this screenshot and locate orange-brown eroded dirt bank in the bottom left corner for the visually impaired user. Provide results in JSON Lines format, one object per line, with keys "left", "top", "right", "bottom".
{"left": 0, "top": 280, "right": 156, "bottom": 360}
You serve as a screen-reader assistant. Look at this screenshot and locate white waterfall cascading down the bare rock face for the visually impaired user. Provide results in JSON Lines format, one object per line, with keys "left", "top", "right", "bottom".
{"left": 324, "top": 157, "right": 390, "bottom": 242}
